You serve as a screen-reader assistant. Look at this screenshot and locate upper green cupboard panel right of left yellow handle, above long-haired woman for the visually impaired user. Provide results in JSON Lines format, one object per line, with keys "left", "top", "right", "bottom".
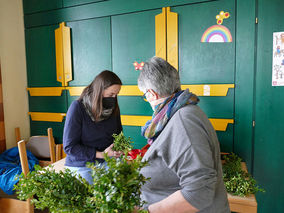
{"left": 67, "top": 17, "right": 111, "bottom": 86}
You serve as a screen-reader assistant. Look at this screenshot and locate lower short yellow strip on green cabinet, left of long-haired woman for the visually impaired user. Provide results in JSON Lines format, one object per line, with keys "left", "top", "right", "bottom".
{"left": 29, "top": 112, "right": 66, "bottom": 122}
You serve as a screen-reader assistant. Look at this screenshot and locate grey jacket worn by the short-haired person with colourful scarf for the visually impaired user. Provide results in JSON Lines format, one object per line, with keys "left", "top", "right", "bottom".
{"left": 141, "top": 105, "right": 230, "bottom": 213}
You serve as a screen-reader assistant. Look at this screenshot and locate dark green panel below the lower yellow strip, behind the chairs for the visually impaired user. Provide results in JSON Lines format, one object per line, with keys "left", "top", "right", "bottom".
{"left": 30, "top": 120, "right": 64, "bottom": 144}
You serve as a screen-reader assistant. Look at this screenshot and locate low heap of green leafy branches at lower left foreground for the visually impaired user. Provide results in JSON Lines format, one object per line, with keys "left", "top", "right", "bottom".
{"left": 15, "top": 165, "right": 94, "bottom": 213}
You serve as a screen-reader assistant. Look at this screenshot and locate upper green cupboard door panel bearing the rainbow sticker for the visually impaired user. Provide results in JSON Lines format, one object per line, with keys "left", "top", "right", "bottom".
{"left": 172, "top": 0, "right": 235, "bottom": 84}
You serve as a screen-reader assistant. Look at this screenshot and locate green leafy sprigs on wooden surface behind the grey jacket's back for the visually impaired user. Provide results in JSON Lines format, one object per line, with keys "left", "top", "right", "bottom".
{"left": 223, "top": 153, "right": 264, "bottom": 197}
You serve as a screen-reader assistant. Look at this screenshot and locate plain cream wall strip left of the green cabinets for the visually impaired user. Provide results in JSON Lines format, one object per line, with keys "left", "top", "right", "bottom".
{"left": 0, "top": 0, "right": 30, "bottom": 149}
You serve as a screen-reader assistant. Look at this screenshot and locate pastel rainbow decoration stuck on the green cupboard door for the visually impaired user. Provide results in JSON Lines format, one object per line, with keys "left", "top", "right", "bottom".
{"left": 201, "top": 25, "right": 233, "bottom": 42}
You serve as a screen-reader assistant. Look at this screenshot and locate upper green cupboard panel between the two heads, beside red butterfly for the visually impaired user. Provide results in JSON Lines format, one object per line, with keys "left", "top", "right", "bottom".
{"left": 111, "top": 10, "right": 159, "bottom": 85}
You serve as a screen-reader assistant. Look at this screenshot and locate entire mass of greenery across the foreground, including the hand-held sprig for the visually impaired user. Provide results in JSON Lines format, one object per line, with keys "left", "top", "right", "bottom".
{"left": 15, "top": 133, "right": 148, "bottom": 213}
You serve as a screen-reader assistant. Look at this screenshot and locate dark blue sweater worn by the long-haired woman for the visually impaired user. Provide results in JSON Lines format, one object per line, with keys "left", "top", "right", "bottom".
{"left": 63, "top": 100, "right": 122, "bottom": 167}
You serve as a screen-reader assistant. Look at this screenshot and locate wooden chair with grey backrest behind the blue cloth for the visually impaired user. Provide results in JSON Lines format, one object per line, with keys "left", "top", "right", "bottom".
{"left": 15, "top": 127, "right": 56, "bottom": 167}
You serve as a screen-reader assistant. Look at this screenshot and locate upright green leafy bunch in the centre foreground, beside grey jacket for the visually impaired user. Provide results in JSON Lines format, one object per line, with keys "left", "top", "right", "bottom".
{"left": 86, "top": 155, "right": 147, "bottom": 213}
